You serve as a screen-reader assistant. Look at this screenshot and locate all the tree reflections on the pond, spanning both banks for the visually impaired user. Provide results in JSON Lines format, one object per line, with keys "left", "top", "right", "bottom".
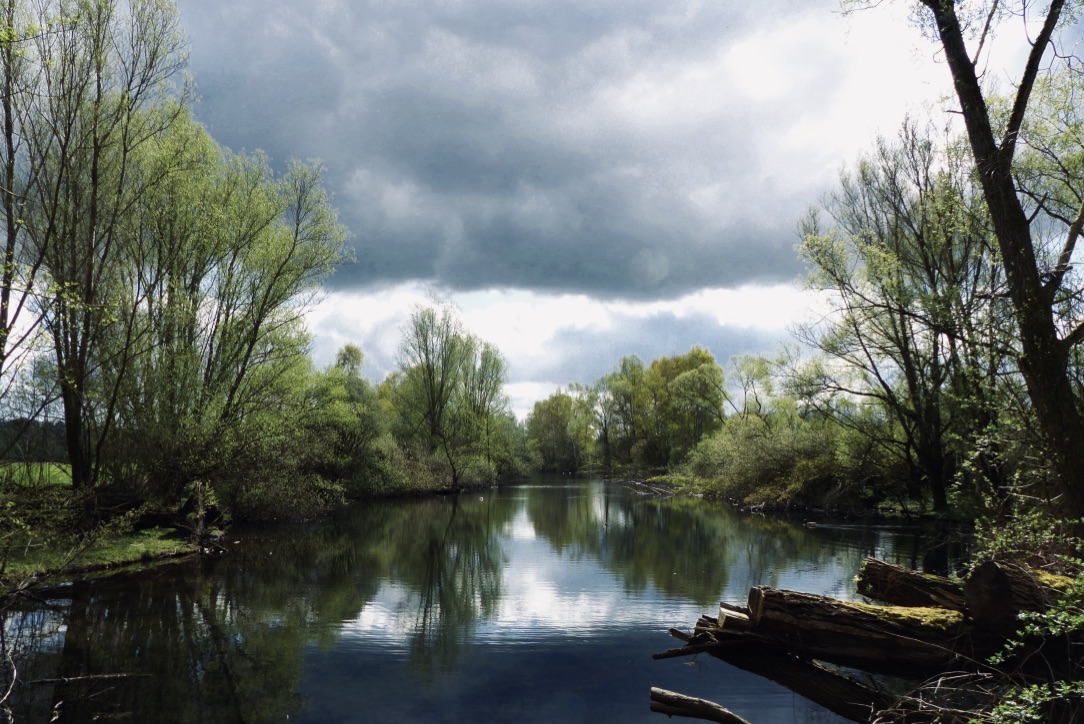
{"left": 0, "top": 482, "right": 966, "bottom": 722}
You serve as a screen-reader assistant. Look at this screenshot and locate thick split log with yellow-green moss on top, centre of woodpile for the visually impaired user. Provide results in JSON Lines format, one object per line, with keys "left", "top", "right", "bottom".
{"left": 749, "top": 586, "right": 1001, "bottom": 675}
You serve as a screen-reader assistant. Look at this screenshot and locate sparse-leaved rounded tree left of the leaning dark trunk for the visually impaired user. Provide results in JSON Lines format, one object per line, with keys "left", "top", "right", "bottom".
{"left": 799, "top": 121, "right": 1011, "bottom": 510}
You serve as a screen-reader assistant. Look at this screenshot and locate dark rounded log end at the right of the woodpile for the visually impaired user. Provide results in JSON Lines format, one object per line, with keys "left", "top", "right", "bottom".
{"left": 964, "top": 560, "right": 1057, "bottom": 628}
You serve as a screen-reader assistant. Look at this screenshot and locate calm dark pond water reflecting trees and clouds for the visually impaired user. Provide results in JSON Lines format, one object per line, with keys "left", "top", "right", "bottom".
{"left": 0, "top": 479, "right": 958, "bottom": 724}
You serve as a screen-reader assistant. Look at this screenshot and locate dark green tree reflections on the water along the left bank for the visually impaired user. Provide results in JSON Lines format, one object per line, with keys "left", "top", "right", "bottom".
{"left": 0, "top": 494, "right": 516, "bottom": 722}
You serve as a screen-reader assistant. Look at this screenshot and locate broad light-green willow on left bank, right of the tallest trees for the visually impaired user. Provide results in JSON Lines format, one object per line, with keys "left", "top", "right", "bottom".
{"left": 104, "top": 115, "right": 344, "bottom": 496}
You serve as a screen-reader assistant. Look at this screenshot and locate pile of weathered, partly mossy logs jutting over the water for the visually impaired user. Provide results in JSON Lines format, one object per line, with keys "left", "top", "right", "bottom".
{"left": 651, "top": 558, "right": 1069, "bottom": 724}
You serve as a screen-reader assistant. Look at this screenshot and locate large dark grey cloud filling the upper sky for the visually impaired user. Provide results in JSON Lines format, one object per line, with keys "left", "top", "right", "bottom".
{"left": 178, "top": 0, "right": 844, "bottom": 298}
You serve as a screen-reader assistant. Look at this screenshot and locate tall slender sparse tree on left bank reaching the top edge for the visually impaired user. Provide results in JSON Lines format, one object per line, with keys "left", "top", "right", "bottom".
{"left": 17, "top": 0, "right": 185, "bottom": 490}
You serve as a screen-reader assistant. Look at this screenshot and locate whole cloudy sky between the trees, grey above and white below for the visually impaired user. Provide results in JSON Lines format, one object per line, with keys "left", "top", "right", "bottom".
{"left": 178, "top": 0, "right": 950, "bottom": 415}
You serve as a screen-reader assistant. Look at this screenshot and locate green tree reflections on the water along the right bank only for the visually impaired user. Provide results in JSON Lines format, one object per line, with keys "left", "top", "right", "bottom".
{"left": 527, "top": 482, "right": 936, "bottom": 606}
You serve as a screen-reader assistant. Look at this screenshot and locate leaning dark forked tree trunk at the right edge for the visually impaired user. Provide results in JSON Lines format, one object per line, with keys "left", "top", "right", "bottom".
{"left": 863, "top": 0, "right": 1084, "bottom": 517}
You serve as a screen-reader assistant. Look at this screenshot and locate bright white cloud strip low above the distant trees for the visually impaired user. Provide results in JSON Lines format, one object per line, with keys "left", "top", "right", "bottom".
{"left": 309, "top": 284, "right": 818, "bottom": 418}
